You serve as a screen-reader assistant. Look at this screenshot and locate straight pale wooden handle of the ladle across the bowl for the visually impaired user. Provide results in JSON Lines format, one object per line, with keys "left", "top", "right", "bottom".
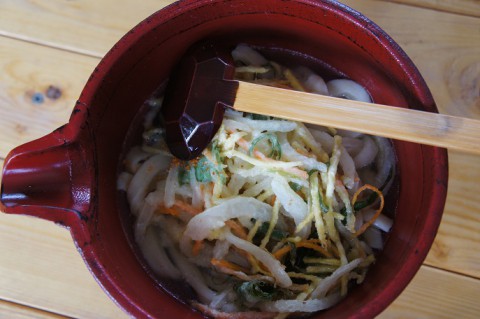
{"left": 234, "top": 81, "right": 480, "bottom": 155}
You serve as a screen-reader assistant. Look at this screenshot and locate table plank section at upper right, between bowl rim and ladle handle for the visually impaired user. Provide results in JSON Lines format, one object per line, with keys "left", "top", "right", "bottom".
{"left": 342, "top": 0, "right": 480, "bottom": 119}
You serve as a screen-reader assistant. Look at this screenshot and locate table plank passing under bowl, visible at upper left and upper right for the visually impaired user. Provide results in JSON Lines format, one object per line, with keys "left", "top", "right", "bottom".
{"left": 0, "top": 0, "right": 480, "bottom": 118}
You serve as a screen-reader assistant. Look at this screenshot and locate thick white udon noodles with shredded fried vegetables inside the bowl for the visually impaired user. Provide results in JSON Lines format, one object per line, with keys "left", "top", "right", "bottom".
{"left": 118, "top": 45, "right": 395, "bottom": 318}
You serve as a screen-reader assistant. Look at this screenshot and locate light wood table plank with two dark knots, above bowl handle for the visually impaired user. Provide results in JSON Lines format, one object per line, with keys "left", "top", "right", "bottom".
{"left": 0, "top": 35, "right": 99, "bottom": 158}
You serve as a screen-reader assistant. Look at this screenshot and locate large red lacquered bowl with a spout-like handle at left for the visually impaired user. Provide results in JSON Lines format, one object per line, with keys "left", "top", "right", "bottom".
{"left": 1, "top": 0, "right": 448, "bottom": 318}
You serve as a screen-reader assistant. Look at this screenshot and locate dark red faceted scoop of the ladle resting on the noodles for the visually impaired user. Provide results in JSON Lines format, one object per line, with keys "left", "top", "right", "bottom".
{"left": 161, "top": 43, "right": 238, "bottom": 160}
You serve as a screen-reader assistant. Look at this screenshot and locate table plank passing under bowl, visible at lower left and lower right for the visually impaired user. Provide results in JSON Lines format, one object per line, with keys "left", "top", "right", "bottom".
{"left": 0, "top": 202, "right": 480, "bottom": 319}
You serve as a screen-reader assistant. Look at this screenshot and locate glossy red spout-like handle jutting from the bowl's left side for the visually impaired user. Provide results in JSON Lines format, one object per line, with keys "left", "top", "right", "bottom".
{"left": 0, "top": 126, "right": 93, "bottom": 228}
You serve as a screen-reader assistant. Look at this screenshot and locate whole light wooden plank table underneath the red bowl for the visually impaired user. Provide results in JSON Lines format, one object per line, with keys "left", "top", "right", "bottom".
{"left": 0, "top": 0, "right": 480, "bottom": 318}
